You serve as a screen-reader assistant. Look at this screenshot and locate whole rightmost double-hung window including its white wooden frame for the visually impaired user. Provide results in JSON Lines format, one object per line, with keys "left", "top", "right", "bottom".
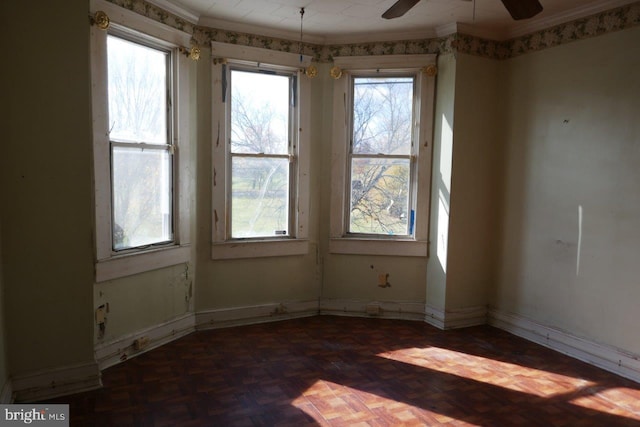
{"left": 330, "top": 55, "right": 435, "bottom": 256}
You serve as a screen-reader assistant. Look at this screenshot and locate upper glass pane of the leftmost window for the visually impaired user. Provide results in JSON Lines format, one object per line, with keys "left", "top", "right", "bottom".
{"left": 107, "top": 36, "right": 168, "bottom": 144}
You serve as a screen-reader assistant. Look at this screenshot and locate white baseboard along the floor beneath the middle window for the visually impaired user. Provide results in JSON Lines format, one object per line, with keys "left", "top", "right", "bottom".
{"left": 196, "top": 300, "right": 318, "bottom": 330}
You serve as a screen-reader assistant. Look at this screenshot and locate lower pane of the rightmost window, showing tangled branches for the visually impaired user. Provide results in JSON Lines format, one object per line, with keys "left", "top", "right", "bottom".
{"left": 349, "top": 158, "right": 412, "bottom": 235}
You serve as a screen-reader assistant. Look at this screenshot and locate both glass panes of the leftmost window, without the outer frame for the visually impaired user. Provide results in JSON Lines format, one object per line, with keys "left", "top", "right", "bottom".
{"left": 107, "top": 35, "right": 173, "bottom": 250}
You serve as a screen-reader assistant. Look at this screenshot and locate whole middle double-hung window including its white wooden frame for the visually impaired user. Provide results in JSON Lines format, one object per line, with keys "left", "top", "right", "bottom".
{"left": 212, "top": 42, "right": 310, "bottom": 259}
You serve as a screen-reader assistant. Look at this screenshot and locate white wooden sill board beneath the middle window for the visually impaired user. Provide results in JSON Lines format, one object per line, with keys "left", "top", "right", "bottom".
{"left": 211, "top": 239, "right": 309, "bottom": 260}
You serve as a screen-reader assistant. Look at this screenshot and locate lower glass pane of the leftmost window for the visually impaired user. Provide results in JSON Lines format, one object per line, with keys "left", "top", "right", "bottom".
{"left": 112, "top": 146, "right": 173, "bottom": 250}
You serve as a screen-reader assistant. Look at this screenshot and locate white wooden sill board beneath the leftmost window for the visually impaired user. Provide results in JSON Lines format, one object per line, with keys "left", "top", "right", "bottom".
{"left": 96, "top": 246, "right": 191, "bottom": 283}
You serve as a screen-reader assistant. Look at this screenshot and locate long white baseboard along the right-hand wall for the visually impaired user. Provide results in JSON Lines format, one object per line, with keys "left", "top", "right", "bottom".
{"left": 488, "top": 309, "right": 640, "bottom": 382}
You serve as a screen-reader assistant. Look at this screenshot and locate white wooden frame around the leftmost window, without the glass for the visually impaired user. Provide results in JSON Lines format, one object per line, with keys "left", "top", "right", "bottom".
{"left": 90, "top": 0, "right": 192, "bottom": 282}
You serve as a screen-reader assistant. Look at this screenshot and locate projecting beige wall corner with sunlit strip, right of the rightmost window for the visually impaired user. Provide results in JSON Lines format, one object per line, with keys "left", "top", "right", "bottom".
{"left": 427, "top": 53, "right": 501, "bottom": 311}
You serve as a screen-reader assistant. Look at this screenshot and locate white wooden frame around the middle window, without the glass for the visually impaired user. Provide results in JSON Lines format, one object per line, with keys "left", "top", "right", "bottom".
{"left": 211, "top": 42, "right": 311, "bottom": 260}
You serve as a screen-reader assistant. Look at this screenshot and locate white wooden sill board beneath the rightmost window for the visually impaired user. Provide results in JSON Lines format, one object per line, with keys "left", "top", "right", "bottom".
{"left": 329, "top": 237, "right": 428, "bottom": 258}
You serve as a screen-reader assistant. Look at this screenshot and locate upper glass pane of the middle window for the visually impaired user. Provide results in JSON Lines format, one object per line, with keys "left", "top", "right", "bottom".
{"left": 231, "top": 70, "right": 290, "bottom": 154}
